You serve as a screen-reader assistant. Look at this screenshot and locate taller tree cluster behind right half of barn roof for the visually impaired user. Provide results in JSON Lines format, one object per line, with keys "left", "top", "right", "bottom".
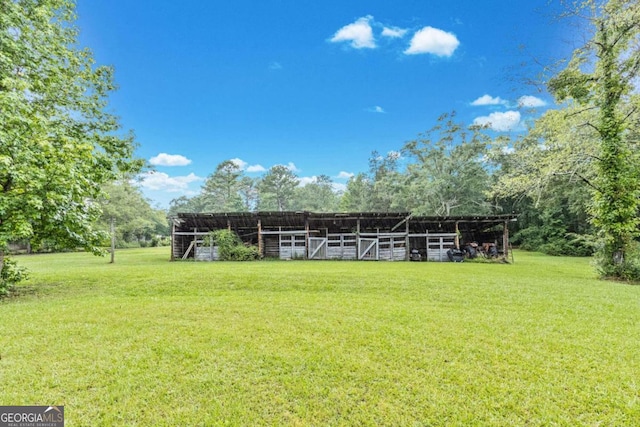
{"left": 340, "top": 113, "right": 493, "bottom": 216}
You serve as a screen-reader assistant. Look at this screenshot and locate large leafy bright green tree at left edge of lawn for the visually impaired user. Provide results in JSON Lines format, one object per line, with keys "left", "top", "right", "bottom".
{"left": 0, "top": 0, "right": 141, "bottom": 264}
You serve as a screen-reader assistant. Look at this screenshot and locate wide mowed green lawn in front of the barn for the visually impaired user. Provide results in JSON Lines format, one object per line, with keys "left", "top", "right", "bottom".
{"left": 0, "top": 248, "right": 640, "bottom": 426}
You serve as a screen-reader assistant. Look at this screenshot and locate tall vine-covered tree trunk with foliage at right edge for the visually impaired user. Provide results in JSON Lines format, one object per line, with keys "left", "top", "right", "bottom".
{"left": 549, "top": 0, "right": 640, "bottom": 279}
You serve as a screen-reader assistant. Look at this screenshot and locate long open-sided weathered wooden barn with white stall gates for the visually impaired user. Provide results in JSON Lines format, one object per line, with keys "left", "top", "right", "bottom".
{"left": 171, "top": 212, "right": 516, "bottom": 261}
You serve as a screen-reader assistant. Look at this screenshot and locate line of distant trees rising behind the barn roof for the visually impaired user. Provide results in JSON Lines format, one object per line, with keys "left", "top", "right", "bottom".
{"left": 169, "top": 113, "right": 495, "bottom": 216}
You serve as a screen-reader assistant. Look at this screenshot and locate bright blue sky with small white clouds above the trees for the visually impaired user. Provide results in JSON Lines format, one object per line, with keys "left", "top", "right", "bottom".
{"left": 77, "top": 0, "right": 571, "bottom": 207}
